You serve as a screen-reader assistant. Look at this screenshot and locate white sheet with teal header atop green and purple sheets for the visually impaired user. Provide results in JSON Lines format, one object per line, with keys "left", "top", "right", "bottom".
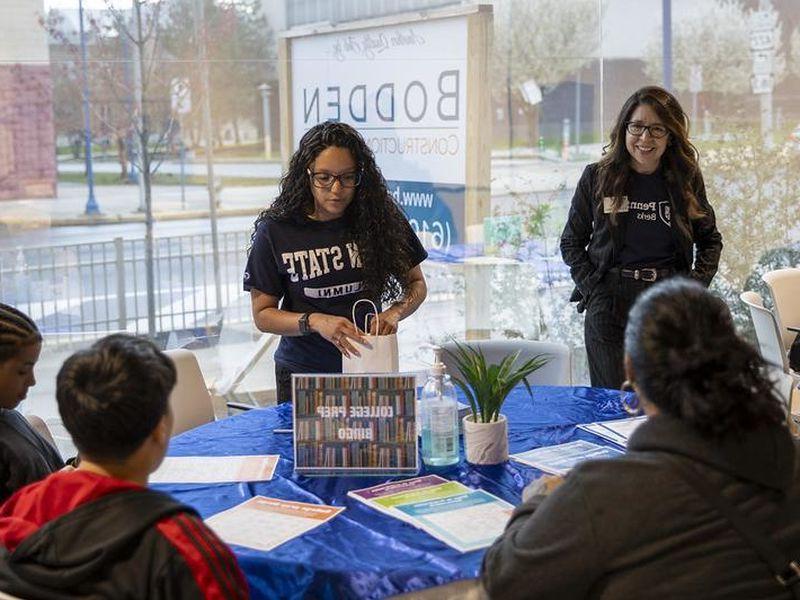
{"left": 395, "top": 490, "right": 514, "bottom": 552}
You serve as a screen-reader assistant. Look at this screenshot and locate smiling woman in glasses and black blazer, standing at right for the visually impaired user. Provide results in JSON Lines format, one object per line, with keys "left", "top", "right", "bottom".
{"left": 561, "top": 86, "right": 722, "bottom": 389}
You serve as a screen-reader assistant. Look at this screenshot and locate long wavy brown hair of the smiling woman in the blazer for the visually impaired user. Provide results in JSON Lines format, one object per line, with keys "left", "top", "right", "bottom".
{"left": 597, "top": 86, "right": 705, "bottom": 226}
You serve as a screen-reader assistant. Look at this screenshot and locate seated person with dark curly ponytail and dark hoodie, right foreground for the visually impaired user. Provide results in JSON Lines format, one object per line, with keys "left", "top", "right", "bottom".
{"left": 482, "top": 278, "right": 800, "bottom": 600}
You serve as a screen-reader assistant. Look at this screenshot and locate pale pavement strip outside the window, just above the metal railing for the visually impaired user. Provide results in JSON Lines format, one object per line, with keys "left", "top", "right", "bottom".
{"left": 0, "top": 183, "right": 278, "bottom": 232}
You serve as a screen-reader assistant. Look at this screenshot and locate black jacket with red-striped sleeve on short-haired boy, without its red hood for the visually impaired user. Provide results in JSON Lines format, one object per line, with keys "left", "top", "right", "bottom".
{"left": 0, "top": 488, "right": 249, "bottom": 600}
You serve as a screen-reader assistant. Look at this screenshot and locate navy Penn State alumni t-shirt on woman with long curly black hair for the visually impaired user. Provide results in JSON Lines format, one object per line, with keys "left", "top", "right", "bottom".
{"left": 244, "top": 217, "right": 428, "bottom": 373}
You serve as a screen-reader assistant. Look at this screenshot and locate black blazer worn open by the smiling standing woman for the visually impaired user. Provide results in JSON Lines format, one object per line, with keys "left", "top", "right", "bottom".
{"left": 561, "top": 163, "right": 722, "bottom": 312}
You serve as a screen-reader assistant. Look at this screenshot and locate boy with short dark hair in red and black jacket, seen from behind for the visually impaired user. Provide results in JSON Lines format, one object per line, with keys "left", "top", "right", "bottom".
{"left": 0, "top": 334, "right": 249, "bottom": 600}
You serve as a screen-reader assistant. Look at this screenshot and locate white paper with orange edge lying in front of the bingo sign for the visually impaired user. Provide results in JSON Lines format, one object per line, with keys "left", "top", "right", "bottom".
{"left": 206, "top": 496, "right": 344, "bottom": 552}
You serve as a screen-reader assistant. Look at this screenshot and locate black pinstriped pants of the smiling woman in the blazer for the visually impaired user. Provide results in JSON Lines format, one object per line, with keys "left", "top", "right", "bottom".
{"left": 583, "top": 272, "right": 653, "bottom": 389}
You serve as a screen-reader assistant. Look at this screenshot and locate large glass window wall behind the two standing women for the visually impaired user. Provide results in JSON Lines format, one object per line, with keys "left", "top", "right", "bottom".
{"left": 0, "top": 0, "right": 800, "bottom": 452}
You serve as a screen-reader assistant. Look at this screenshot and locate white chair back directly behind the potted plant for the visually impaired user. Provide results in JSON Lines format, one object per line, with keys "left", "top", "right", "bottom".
{"left": 442, "top": 340, "right": 572, "bottom": 385}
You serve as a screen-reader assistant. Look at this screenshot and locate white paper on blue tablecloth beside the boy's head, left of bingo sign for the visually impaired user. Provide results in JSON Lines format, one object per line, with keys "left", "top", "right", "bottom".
{"left": 150, "top": 454, "right": 280, "bottom": 483}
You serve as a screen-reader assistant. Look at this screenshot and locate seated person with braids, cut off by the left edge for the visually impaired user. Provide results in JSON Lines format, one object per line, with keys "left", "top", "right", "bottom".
{"left": 0, "top": 304, "right": 64, "bottom": 504}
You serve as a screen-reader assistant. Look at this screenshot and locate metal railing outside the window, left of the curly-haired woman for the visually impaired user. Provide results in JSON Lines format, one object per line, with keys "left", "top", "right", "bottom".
{"left": 0, "top": 231, "right": 251, "bottom": 340}
